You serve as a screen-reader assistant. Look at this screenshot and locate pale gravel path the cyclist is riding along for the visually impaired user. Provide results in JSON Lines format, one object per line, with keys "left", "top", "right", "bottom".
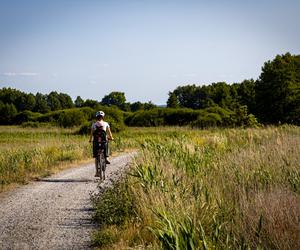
{"left": 0, "top": 154, "right": 133, "bottom": 250}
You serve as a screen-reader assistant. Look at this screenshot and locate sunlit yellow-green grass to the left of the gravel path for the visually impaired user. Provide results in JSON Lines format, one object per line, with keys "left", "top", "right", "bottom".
{"left": 0, "top": 126, "right": 91, "bottom": 190}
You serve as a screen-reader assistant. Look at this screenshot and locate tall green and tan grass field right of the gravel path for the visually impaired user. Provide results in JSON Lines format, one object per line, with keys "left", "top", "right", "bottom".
{"left": 94, "top": 126, "right": 300, "bottom": 249}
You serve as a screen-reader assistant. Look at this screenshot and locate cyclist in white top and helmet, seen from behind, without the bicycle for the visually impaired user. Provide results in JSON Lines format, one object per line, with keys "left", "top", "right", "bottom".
{"left": 89, "top": 111, "right": 114, "bottom": 164}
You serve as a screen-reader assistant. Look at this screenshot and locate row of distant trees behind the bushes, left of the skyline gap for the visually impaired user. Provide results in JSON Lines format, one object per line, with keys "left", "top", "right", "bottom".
{"left": 0, "top": 88, "right": 156, "bottom": 124}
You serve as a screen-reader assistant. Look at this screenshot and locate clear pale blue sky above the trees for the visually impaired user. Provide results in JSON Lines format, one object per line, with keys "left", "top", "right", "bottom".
{"left": 0, "top": 0, "right": 300, "bottom": 104}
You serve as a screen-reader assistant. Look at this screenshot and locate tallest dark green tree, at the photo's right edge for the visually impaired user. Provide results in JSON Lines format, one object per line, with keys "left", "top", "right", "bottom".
{"left": 255, "top": 53, "right": 300, "bottom": 124}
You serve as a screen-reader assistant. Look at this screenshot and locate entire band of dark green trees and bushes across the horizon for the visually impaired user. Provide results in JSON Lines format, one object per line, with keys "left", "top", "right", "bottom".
{"left": 0, "top": 53, "right": 300, "bottom": 127}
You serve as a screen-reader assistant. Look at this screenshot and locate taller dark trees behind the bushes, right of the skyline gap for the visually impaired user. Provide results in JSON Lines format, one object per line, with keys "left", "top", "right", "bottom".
{"left": 167, "top": 53, "right": 300, "bottom": 124}
